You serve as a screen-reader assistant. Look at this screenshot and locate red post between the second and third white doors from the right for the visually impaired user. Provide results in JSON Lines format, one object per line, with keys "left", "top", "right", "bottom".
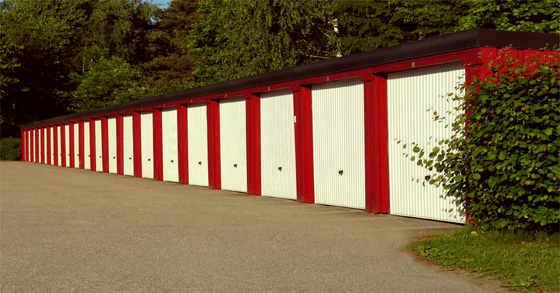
{"left": 292, "top": 85, "right": 315, "bottom": 203}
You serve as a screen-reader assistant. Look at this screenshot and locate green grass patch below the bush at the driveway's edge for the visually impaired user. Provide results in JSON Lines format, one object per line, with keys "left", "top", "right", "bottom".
{"left": 408, "top": 227, "right": 560, "bottom": 292}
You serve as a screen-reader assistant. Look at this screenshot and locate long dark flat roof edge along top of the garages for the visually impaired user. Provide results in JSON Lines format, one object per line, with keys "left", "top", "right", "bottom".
{"left": 20, "top": 29, "right": 560, "bottom": 128}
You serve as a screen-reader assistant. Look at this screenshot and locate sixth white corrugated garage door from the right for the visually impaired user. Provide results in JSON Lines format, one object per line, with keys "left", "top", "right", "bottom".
{"left": 161, "top": 109, "right": 179, "bottom": 182}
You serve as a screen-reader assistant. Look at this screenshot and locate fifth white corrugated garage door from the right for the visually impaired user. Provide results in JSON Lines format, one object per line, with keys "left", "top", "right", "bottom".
{"left": 187, "top": 104, "right": 208, "bottom": 186}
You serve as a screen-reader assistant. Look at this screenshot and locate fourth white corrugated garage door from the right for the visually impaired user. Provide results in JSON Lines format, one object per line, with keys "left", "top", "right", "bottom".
{"left": 220, "top": 98, "right": 247, "bottom": 192}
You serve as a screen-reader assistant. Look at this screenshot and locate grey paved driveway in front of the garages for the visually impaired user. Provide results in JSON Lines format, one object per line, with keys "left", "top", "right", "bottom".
{"left": 0, "top": 162, "right": 506, "bottom": 292}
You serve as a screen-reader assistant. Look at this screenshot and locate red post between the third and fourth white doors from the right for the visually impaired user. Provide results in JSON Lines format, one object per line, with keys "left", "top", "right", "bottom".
{"left": 244, "top": 94, "right": 261, "bottom": 195}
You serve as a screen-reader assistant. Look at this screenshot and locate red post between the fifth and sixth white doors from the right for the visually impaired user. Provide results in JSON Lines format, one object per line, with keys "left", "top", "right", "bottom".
{"left": 177, "top": 105, "right": 189, "bottom": 184}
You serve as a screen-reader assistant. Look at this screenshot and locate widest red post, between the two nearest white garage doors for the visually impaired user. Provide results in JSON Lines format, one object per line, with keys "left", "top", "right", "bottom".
{"left": 362, "top": 74, "right": 389, "bottom": 214}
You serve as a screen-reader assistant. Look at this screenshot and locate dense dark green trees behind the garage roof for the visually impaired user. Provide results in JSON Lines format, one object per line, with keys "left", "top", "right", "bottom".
{"left": 0, "top": 0, "right": 560, "bottom": 137}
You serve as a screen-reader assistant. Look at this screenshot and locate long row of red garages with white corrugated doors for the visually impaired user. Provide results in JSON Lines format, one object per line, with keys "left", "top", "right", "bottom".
{"left": 18, "top": 31, "right": 556, "bottom": 223}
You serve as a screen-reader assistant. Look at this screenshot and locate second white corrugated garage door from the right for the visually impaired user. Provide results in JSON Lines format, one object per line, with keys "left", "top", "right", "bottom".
{"left": 311, "top": 78, "right": 366, "bottom": 209}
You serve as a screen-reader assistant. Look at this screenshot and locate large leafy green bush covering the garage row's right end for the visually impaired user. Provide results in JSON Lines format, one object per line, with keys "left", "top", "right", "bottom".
{"left": 404, "top": 51, "right": 560, "bottom": 231}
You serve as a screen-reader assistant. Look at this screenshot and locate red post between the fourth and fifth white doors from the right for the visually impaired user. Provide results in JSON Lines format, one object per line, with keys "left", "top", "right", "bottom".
{"left": 206, "top": 100, "right": 222, "bottom": 189}
